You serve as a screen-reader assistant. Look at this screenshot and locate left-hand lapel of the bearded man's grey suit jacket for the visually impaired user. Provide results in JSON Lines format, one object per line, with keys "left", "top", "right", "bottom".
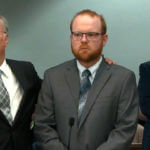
{"left": 65, "top": 60, "right": 80, "bottom": 108}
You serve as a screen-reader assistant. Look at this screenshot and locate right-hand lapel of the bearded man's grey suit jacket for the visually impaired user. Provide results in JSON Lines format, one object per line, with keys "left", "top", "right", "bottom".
{"left": 79, "top": 60, "right": 111, "bottom": 128}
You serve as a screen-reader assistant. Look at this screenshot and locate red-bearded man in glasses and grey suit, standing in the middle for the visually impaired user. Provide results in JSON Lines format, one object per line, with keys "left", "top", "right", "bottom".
{"left": 33, "top": 10, "right": 139, "bottom": 150}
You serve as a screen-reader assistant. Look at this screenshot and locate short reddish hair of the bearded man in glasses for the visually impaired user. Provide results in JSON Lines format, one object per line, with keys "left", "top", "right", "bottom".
{"left": 70, "top": 9, "right": 107, "bottom": 34}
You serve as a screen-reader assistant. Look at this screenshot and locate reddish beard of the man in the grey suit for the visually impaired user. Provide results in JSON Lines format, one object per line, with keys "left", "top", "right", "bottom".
{"left": 71, "top": 45, "right": 103, "bottom": 63}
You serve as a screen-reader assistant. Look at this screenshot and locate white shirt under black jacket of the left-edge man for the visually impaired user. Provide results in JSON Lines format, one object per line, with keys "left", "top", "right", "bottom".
{"left": 0, "top": 60, "right": 23, "bottom": 120}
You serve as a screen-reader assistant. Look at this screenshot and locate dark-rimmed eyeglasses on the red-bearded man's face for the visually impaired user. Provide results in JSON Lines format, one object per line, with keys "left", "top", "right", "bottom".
{"left": 71, "top": 32, "right": 103, "bottom": 41}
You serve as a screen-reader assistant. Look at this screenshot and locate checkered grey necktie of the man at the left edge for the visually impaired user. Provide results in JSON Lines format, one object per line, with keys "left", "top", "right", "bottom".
{"left": 0, "top": 70, "right": 12, "bottom": 125}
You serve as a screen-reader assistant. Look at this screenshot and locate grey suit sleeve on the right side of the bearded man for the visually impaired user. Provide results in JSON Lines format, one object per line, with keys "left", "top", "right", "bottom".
{"left": 96, "top": 73, "right": 139, "bottom": 150}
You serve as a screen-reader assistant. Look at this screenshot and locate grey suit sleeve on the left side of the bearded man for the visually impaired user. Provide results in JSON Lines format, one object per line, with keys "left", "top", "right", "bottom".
{"left": 33, "top": 70, "right": 66, "bottom": 150}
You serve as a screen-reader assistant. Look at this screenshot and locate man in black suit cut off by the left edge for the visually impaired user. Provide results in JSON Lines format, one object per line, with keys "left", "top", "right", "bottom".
{"left": 0, "top": 16, "right": 41, "bottom": 150}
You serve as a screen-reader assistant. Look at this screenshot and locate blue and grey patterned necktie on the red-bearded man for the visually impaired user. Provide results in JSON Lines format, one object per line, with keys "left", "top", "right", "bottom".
{"left": 78, "top": 69, "right": 91, "bottom": 122}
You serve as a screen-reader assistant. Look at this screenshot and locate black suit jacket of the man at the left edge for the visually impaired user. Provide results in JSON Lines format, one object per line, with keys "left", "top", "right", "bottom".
{"left": 0, "top": 59, "right": 41, "bottom": 150}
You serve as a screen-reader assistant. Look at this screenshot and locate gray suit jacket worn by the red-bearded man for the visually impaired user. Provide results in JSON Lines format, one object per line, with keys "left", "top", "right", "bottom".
{"left": 33, "top": 60, "right": 138, "bottom": 150}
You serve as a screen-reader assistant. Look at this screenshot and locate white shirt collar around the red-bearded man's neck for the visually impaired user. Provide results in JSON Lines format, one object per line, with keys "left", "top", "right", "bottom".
{"left": 77, "top": 57, "right": 102, "bottom": 84}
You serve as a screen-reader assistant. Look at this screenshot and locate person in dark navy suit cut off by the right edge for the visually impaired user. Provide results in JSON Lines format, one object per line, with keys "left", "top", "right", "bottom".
{"left": 138, "top": 61, "right": 150, "bottom": 150}
